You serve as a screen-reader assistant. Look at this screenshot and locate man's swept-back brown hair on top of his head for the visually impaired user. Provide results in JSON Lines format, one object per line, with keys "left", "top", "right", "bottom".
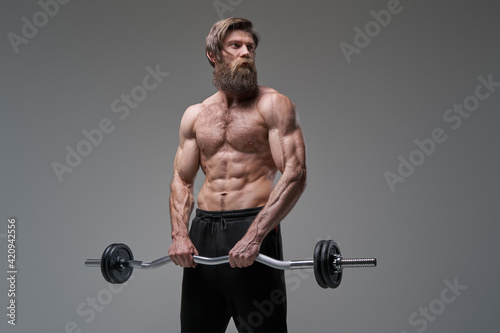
{"left": 205, "top": 17, "right": 259, "bottom": 67}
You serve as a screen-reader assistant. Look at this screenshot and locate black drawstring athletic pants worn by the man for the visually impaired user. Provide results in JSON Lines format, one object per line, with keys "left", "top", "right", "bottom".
{"left": 181, "top": 207, "right": 287, "bottom": 332}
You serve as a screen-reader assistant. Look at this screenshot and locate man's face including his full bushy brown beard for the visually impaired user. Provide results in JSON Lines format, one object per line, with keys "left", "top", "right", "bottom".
{"left": 214, "top": 30, "right": 257, "bottom": 95}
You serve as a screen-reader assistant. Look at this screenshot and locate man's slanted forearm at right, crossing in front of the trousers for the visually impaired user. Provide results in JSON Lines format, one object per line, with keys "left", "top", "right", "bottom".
{"left": 247, "top": 167, "right": 307, "bottom": 243}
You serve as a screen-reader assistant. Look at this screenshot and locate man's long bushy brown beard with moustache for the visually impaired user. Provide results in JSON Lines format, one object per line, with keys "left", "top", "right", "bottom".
{"left": 213, "top": 59, "right": 257, "bottom": 96}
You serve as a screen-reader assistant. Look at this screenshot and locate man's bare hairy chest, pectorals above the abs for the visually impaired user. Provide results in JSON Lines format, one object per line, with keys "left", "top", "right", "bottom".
{"left": 196, "top": 105, "right": 269, "bottom": 156}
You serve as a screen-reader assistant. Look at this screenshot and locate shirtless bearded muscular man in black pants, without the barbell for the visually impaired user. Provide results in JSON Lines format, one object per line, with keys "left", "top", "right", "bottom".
{"left": 169, "top": 18, "right": 306, "bottom": 332}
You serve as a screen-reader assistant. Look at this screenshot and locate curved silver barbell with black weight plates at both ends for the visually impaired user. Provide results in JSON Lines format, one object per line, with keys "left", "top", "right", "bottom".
{"left": 85, "top": 240, "right": 377, "bottom": 289}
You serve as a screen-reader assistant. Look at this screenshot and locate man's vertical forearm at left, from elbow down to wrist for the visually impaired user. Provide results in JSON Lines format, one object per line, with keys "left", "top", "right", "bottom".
{"left": 169, "top": 176, "right": 194, "bottom": 239}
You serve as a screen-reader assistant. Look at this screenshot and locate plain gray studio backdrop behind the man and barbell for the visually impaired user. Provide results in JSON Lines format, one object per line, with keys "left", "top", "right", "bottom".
{"left": 0, "top": 0, "right": 500, "bottom": 333}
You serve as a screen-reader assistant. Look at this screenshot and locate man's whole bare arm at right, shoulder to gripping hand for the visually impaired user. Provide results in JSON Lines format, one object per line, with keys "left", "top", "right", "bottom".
{"left": 229, "top": 92, "right": 307, "bottom": 267}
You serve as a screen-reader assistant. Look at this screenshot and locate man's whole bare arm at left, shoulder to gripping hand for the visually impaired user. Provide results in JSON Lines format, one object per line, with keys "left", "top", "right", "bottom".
{"left": 168, "top": 105, "right": 201, "bottom": 267}
